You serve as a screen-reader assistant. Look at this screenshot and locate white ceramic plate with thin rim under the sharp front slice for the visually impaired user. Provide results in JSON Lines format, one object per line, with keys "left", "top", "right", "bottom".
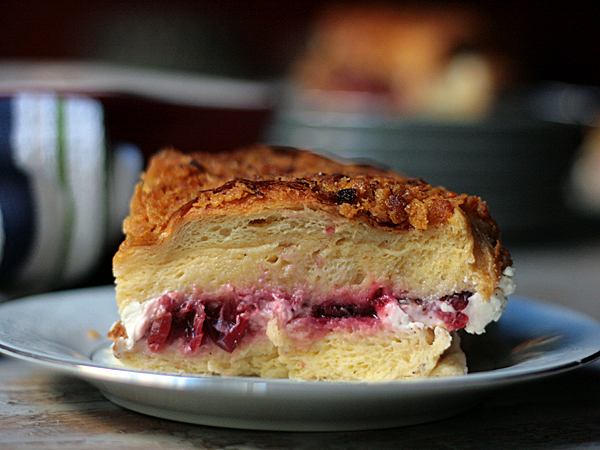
{"left": 0, "top": 287, "right": 600, "bottom": 431}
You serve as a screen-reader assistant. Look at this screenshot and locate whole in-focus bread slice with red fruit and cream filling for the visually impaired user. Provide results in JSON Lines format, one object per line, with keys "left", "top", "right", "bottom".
{"left": 110, "top": 147, "right": 513, "bottom": 380}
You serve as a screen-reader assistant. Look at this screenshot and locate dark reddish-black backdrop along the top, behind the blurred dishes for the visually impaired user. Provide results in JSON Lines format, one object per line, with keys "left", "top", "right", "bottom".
{"left": 0, "top": 0, "right": 600, "bottom": 84}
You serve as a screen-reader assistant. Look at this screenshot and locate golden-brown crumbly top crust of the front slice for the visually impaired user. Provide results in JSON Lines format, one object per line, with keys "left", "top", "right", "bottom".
{"left": 122, "top": 146, "right": 511, "bottom": 269}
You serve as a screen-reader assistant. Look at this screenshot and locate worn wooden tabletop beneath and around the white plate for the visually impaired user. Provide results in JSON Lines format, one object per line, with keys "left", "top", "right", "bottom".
{"left": 0, "top": 237, "right": 600, "bottom": 450}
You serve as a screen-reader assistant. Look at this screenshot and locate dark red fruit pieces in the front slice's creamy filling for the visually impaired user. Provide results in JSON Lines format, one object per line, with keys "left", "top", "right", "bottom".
{"left": 147, "top": 289, "right": 470, "bottom": 354}
